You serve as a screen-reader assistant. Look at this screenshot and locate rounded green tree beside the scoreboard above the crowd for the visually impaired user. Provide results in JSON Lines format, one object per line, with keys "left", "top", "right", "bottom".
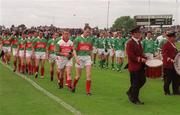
{"left": 112, "top": 16, "right": 136, "bottom": 32}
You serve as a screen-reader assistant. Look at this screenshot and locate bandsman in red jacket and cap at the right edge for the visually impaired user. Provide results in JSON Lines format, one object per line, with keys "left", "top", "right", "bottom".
{"left": 162, "top": 32, "right": 180, "bottom": 95}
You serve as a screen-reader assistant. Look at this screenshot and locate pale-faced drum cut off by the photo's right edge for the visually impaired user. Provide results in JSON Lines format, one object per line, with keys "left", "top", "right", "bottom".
{"left": 174, "top": 52, "right": 180, "bottom": 75}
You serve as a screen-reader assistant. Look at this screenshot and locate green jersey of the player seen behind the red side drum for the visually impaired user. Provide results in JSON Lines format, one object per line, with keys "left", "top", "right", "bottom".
{"left": 141, "top": 38, "right": 157, "bottom": 54}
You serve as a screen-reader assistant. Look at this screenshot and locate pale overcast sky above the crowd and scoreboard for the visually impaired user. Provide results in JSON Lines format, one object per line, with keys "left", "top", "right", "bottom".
{"left": 0, "top": 0, "right": 180, "bottom": 28}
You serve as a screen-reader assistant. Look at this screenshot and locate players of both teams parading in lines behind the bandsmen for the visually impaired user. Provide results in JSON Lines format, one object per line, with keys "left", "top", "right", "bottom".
{"left": 0, "top": 27, "right": 165, "bottom": 95}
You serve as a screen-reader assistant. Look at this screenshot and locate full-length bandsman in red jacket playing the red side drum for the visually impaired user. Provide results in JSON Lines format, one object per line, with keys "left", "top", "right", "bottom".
{"left": 126, "top": 27, "right": 146, "bottom": 105}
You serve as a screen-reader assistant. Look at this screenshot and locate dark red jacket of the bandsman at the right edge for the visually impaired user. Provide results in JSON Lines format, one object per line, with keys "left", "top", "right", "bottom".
{"left": 162, "top": 41, "right": 177, "bottom": 69}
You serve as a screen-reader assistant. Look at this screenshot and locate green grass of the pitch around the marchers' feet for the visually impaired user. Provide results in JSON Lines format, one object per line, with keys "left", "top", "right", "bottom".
{"left": 0, "top": 42, "right": 180, "bottom": 115}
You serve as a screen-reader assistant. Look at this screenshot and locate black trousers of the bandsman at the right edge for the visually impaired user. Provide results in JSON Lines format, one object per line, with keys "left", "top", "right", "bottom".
{"left": 164, "top": 68, "right": 179, "bottom": 94}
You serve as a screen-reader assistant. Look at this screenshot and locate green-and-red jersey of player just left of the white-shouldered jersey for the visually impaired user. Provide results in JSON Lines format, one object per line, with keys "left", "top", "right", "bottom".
{"left": 47, "top": 38, "right": 56, "bottom": 54}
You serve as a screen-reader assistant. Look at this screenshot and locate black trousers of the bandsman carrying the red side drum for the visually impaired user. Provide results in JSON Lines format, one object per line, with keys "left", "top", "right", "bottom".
{"left": 128, "top": 69, "right": 146, "bottom": 101}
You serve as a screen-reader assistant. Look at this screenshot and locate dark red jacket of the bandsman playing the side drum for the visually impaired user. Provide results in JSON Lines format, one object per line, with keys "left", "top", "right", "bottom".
{"left": 126, "top": 39, "right": 145, "bottom": 72}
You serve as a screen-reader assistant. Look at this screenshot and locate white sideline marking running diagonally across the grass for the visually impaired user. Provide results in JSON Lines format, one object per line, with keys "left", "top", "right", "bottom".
{"left": 0, "top": 61, "right": 81, "bottom": 115}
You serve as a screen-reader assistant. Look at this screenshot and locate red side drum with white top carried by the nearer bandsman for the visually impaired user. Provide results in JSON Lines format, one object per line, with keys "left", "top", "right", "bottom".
{"left": 146, "top": 59, "right": 163, "bottom": 78}
